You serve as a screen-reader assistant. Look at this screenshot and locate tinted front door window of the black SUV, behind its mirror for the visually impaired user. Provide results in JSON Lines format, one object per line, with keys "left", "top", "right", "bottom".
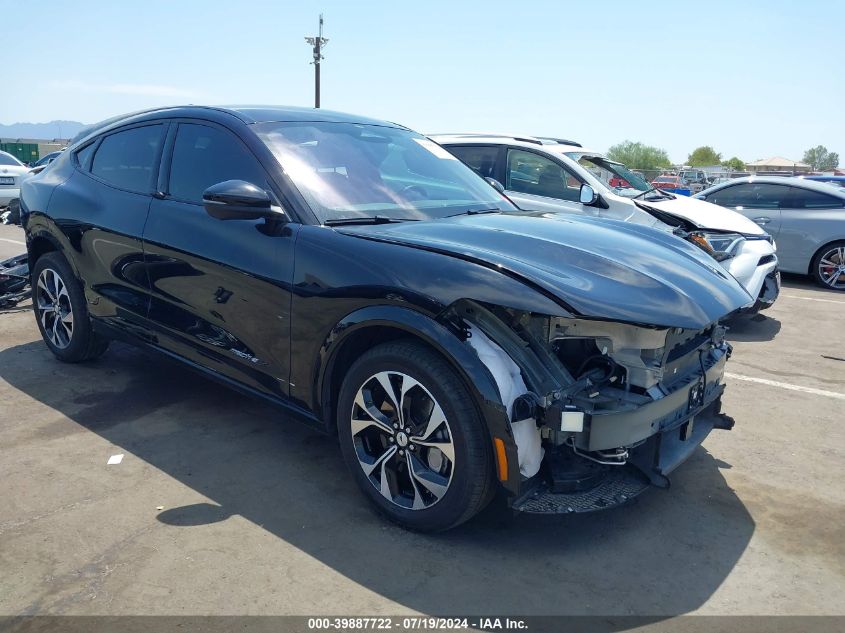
{"left": 168, "top": 123, "right": 267, "bottom": 204}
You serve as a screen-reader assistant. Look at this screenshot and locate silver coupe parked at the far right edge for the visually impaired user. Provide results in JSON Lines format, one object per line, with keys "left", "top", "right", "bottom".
{"left": 694, "top": 176, "right": 845, "bottom": 290}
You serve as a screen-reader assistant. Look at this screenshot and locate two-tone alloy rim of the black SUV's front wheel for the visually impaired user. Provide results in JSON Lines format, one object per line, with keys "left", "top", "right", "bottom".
{"left": 351, "top": 371, "right": 455, "bottom": 510}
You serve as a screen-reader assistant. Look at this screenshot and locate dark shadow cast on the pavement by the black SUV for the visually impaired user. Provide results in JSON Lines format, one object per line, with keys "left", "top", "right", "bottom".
{"left": 0, "top": 341, "right": 754, "bottom": 618}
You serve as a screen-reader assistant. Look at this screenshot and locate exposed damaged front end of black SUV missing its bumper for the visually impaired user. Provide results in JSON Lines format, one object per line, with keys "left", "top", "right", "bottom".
{"left": 444, "top": 300, "right": 733, "bottom": 513}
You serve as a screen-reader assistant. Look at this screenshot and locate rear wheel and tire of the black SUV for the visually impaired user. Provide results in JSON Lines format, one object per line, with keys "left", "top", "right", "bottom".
{"left": 32, "top": 251, "right": 109, "bottom": 363}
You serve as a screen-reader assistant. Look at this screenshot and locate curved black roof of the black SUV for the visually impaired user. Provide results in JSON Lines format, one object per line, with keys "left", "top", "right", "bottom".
{"left": 69, "top": 105, "right": 403, "bottom": 145}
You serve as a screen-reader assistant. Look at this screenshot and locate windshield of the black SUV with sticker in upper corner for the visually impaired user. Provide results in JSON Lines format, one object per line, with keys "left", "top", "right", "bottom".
{"left": 254, "top": 121, "right": 516, "bottom": 222}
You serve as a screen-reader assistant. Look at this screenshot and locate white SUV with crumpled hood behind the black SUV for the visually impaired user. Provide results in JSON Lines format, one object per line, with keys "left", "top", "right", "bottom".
{"left": 430, "top": 134, "right": 780, "bottom": 310}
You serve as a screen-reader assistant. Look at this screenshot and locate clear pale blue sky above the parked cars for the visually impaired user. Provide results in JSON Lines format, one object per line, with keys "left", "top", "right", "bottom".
{"left": 0, "top": 0, "right": 845, "bottom": 162}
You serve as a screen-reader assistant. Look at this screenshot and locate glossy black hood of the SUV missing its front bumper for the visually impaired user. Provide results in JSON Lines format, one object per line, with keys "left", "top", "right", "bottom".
{"left": 338, "top": 213, "right": 753, "bottom": 329}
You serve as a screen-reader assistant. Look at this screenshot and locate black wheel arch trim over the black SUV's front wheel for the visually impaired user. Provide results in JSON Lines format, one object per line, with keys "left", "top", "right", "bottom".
{"left": 314, "top": 306, "right": 519, "bottom": 494}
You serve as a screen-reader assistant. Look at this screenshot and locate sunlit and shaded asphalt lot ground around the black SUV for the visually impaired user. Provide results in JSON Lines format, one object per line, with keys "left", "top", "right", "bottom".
{"left": 0, "top": 220, "right": 845, "bottom": 616}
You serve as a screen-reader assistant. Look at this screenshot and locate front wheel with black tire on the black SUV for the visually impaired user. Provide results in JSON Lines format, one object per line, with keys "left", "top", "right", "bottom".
{"left": 337, "top": 341, "right": 495, "bottom": 532}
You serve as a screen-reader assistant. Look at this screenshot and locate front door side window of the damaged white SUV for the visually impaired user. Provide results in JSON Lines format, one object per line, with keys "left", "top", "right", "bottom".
{"left": 505, "top": 149, "right": 581, "bottom": 202}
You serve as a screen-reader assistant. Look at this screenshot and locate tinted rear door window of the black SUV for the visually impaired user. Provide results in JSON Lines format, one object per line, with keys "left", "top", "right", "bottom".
{"left": 91, "top": 124, "right": 164, "bottom": 193}
